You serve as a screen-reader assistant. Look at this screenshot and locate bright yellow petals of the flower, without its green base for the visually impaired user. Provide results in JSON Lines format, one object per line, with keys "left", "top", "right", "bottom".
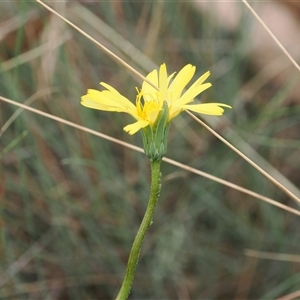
{"left": 81, "top": 64, "right": 231, "bottom": 134}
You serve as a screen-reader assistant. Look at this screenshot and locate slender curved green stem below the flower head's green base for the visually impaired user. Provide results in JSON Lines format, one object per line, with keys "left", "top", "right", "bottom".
{"left": 116, "top": 160, "right": 161, "bottom": 300}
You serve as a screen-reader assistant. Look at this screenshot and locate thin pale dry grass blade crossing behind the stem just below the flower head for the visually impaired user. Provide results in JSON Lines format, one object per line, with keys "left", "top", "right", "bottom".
{"left": 0, "top": 96, "right": 300, "bottom": 216}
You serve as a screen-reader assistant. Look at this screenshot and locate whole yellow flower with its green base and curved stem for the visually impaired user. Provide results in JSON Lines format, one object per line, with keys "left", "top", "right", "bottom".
{"left": 81, "top": 64, "right": 231, "bottom": 300}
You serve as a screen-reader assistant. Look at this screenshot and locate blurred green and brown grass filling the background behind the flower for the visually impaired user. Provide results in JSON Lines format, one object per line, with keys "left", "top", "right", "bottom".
{"left": 0, "top": 1, "right": 300, "bottom": 300}
